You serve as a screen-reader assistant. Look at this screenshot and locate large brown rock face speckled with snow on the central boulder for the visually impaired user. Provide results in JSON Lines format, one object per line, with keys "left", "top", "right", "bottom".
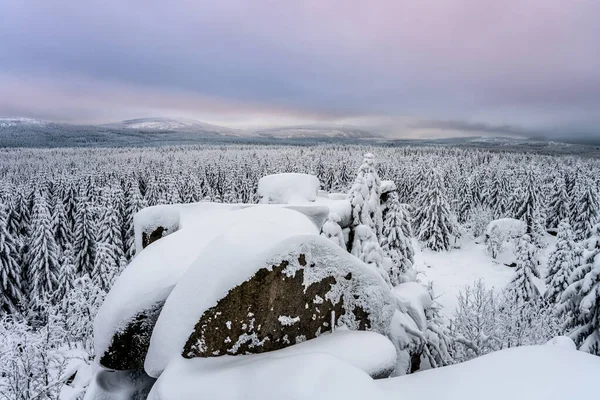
{"left": 182, "top": 245, "right": 391, "bottom": 358}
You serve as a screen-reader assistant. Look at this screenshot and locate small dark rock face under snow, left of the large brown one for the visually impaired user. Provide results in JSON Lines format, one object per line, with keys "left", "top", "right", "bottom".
{"left": 99, "top": 301, "right": 165, "bottom": 371}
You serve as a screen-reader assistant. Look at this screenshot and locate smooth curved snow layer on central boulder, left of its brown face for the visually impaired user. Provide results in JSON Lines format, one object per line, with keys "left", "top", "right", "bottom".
{"left": 142, "top": 206, "right": 319, "bottom": 376}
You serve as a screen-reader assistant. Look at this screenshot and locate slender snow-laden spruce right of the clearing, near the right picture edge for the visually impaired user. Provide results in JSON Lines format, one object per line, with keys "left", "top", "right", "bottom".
{"left": 545, "top": 220, "right": 582, "bottom": 304}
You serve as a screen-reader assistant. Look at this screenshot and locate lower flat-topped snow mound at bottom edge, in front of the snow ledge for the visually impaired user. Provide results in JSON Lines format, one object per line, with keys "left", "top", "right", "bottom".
{"left": 148, "top": 353, "right": 382, "bottom": 400}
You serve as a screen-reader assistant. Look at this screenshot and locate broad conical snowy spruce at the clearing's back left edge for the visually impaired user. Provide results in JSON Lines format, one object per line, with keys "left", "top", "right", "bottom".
{"left": 414, "top": 171, "right": 455, "bottom": 251}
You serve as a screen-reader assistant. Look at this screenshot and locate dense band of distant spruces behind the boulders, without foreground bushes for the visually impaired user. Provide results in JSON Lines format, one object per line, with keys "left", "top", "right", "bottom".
{"left": 0, "top": 146, "right": 600, "bottom": 313}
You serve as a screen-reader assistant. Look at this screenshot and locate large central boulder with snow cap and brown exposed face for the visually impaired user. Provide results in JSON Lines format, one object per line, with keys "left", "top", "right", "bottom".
{"left": 145, "top": 227, "right": 395, "bottom": 377}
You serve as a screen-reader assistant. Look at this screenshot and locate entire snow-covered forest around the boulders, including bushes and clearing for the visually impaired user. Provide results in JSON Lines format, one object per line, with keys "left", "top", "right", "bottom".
{"left": 0, "top": 145, "right": 600, "bottom": 400}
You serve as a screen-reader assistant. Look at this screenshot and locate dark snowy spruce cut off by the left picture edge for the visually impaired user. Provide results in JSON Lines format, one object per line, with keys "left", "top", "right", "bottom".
{"left": 0, "top": 204, "right": 24, "bottom": 315}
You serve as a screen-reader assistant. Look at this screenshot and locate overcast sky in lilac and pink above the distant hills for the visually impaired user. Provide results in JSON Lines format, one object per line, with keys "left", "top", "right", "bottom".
{"left": 0, "top": 0, "right": 600, "bottom": 138}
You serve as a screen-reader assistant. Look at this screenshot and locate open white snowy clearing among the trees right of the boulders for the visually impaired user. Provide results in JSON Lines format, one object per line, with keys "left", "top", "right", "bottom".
{"left": 413, "top": 235, "right": 555, "bottom": 316}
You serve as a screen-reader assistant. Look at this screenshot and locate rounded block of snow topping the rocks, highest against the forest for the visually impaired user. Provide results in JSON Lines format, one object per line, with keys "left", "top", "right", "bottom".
{"left": 258, "top": 173, "right": 321, "bottom": 204}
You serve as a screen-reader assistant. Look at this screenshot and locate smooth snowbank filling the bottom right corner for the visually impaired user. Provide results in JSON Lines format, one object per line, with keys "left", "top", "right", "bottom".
{"left": 374, "top": 346, "right": 600, "bottom": 400}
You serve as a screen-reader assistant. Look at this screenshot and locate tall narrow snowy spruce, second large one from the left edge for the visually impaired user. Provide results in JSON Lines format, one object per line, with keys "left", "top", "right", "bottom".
{"left": 26, "top": 192, "right": 60, "bottom": 304}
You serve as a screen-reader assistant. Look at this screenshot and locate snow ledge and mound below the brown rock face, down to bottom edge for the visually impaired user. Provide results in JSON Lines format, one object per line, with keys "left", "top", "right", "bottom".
{"left": 149, "top": 330, "right": 396, "bottom": 400}
